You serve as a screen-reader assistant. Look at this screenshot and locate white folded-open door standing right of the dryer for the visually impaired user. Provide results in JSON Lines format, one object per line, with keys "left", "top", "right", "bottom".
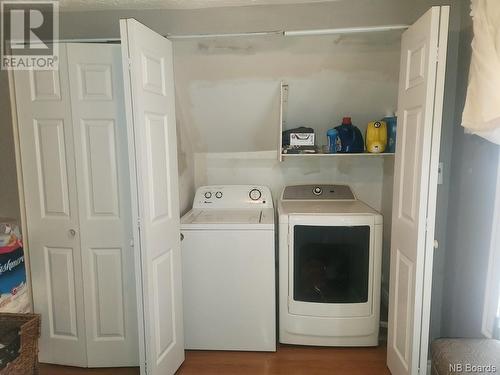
{"left": 387, "top": 7, "right": 449, "bottom": 375}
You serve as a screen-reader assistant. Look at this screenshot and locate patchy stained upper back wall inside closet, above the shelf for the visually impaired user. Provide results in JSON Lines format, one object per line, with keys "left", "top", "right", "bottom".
{"left": 174, "top": 32, "right": 400, "bottom": 152}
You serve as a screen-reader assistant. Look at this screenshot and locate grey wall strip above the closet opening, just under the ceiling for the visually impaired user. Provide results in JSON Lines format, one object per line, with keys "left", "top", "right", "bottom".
{"left": 60, "top": 0, "right": 422, "bottom": 38}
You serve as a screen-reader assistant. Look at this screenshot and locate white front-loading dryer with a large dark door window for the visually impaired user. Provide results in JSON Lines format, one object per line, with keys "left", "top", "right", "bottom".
{"left": 278, "top": 185, "right": 382, "bottom": 346}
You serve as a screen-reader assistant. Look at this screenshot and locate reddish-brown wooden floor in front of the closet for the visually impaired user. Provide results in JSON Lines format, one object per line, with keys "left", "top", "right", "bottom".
{"left": 40, "top": 345, "right": 390, "bottom": 375}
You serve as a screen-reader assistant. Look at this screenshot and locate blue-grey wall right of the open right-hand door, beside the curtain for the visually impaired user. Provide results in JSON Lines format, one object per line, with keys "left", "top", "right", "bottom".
{"left": 441, "top": 4, "right": 500, "bottom": 337}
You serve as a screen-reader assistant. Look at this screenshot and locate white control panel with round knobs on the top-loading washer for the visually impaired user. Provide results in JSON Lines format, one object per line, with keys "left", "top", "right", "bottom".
{"left": 193, "top": 185, "right": 273, "bottom": 209}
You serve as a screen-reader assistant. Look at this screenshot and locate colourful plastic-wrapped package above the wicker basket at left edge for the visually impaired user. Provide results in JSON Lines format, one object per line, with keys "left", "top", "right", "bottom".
{"left": 0, "top": 219, "right": 30, "bottom": 313}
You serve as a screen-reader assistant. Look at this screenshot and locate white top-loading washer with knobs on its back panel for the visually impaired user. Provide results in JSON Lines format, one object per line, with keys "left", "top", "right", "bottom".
{"left": 181, "top": 185, "right": 276, "bottom": 351}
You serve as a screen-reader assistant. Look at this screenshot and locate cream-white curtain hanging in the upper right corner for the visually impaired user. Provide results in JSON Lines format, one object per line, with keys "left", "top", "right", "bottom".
{"left": 462, "top": 0, "right": 500, "bottom": 144}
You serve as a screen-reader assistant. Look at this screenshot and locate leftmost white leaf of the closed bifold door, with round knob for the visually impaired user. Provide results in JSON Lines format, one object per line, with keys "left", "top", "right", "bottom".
{"left": 14, "top": 45, "right": 87, "bottom": 366}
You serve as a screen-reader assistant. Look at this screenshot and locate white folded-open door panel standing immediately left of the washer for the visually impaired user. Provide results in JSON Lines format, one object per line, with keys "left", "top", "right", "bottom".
{"left": 120, "top": 19, "right": 184, "bottom": 375}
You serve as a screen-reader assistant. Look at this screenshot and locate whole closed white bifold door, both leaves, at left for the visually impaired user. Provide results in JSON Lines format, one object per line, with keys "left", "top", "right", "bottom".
{"left": 14, "top": 44, "right": 139, "bottom": 367}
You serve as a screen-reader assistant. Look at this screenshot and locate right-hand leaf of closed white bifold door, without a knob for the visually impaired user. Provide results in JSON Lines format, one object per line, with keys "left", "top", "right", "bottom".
{"left": 67, "top": 43, "right": 139, "bottom": 367}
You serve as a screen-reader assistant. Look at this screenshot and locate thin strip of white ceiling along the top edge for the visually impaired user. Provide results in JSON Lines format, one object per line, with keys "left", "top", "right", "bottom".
{"left": 59, "top": 0, "right": 339, "bottom": 11}
